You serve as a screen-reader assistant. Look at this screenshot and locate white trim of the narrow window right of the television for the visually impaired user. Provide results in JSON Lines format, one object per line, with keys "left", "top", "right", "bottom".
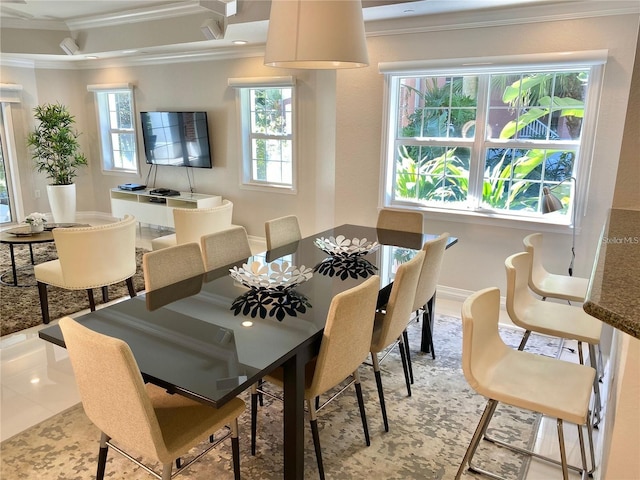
{"left": 227, "top": 76, "right": 298, "bottom": 195}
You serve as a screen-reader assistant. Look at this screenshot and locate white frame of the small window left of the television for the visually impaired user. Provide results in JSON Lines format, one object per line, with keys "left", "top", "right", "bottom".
{"left": 87, "top": 83, "right": 140, "bottom": 175}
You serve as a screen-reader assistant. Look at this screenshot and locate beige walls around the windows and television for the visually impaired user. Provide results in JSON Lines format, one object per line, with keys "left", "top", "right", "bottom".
{"left": 0, "top": 15, "right": 638, "bottom": 295}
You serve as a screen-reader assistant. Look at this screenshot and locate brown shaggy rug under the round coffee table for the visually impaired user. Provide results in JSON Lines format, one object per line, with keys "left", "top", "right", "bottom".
{"left": 0, "top": 243, "right": 145, "bottom": 336}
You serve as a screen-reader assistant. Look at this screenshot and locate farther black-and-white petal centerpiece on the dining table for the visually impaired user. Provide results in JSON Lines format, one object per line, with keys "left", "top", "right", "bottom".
{"left": 314, "top": 235, "right": 380, "bottom": 280}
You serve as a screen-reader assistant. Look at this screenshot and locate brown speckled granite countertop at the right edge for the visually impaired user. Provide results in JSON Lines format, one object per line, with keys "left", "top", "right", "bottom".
{"left": 583, "top": 208, "right": 640, "bottom": 338}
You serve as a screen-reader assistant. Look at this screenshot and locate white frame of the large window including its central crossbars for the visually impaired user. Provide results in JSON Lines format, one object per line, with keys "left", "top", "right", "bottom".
{"left": 379, "top": 50, "right": 608, "bottom": 227}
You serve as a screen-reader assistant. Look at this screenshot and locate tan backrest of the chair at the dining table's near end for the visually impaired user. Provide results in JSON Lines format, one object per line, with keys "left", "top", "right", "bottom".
{"left": 60, "top": 317, "right": 167, "bottom": 459}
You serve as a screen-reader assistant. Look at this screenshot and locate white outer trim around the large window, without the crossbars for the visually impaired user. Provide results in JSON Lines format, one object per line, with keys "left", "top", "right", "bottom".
{"left": 378, "top": 50, "right": 608, "bottom": 232}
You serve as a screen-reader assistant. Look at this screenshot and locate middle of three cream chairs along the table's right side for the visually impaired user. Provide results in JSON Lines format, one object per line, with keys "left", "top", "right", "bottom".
{"left": 370, "top": 251, "right": 425, "bottom": 432}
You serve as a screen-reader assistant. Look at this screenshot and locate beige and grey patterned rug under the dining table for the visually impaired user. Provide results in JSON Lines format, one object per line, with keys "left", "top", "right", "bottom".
{"left": 0, "top": 316, "right": 559, "bottom": 480}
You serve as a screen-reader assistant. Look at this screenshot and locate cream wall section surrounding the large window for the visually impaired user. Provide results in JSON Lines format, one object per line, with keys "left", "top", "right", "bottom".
{"left": 336, "top": 15, "right": 640, "bottom": 295}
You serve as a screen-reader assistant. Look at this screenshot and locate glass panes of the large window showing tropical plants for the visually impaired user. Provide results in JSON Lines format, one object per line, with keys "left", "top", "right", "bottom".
{"left": 381, "top": 52, "right": 602, "bottom": 224}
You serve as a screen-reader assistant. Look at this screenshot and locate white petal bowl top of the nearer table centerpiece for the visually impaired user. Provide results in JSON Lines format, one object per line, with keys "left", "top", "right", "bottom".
{"left": 229, "top": 261, "right": 313, "bottom": 290}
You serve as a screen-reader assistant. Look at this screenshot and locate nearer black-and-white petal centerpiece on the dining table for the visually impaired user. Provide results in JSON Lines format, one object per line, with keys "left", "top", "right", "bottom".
{"left": 229, "top": 261, "right": 313, "bottom": 321}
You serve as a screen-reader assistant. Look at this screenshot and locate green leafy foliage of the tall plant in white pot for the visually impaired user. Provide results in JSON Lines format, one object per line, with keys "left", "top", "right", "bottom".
{"left": 27, "top": 103, "right": 87, "bottom": 185}
